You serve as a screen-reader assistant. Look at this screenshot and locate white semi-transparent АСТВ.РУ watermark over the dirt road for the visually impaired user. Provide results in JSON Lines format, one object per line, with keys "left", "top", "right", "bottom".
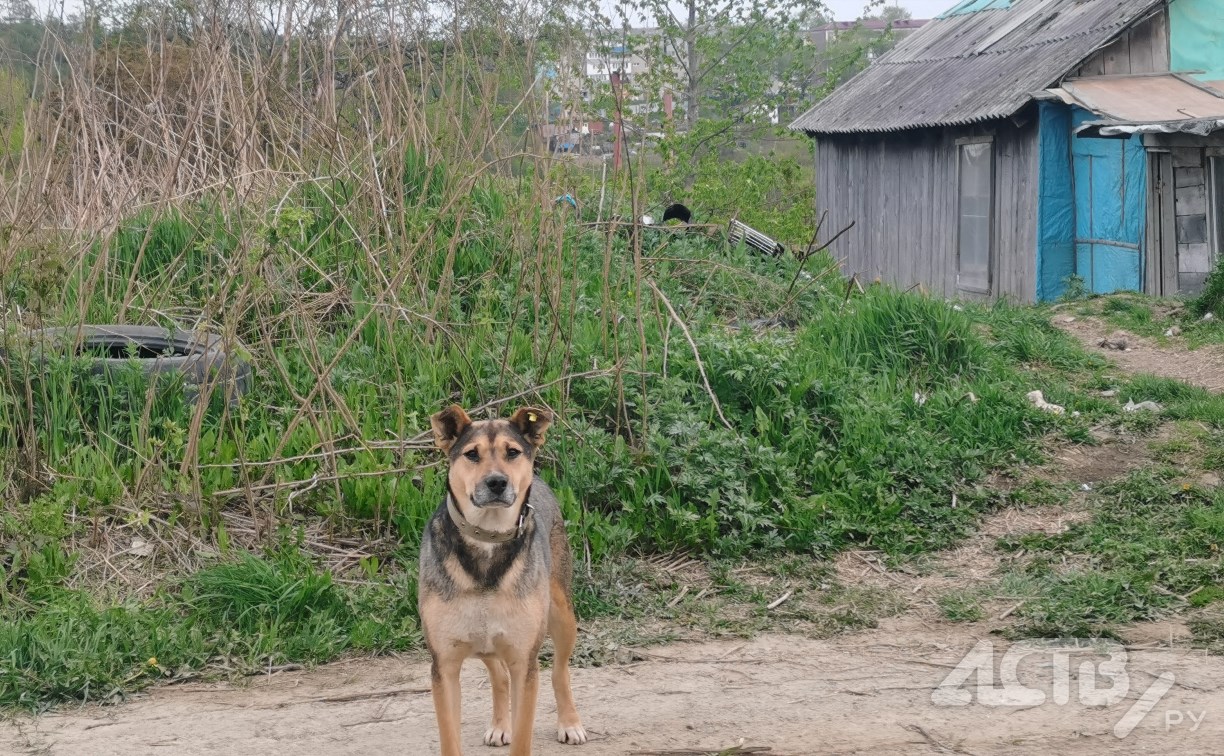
{"left": 930, "top": 639, "right": 1207, "bottom": 738}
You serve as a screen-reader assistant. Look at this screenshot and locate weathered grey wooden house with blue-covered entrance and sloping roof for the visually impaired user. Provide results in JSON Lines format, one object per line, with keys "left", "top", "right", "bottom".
{"left": 791, "top": 0, "right": 1224, "bottom": 302}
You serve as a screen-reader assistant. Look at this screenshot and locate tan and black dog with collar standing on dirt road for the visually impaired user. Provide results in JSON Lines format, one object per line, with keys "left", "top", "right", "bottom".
{"left": 417, "top": 405, "right": 586, "bottom": 756}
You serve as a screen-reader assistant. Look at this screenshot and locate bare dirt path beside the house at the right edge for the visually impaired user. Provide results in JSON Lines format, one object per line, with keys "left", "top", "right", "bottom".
{"left": 1053, "top": 314, "right": 1224, "bottom": 391}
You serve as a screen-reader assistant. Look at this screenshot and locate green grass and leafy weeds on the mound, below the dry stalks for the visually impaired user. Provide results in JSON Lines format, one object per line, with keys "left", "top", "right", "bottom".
{"left": 0, "top": 150, "right": 1116, "bottom": 703}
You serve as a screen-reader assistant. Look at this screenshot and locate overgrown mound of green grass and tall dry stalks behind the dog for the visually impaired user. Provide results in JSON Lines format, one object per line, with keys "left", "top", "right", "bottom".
{"left": 0, "top": 0, "right": 1224, "bottom": 706}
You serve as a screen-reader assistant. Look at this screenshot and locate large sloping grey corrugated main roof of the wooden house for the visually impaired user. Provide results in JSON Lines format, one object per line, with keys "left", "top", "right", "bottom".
{"left": 791, "top": 0, "right": 1163, "bottom": 135}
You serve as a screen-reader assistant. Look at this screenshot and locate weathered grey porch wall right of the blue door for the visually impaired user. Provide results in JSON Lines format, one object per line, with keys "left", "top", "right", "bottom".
{"left": 1147, "top": 133, "right": 1224, "bottom": 295}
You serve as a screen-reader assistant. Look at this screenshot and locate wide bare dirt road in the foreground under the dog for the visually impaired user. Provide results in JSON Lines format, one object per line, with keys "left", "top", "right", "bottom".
{"left": 7, "top": 619, "right": 1224, "bottom": 756}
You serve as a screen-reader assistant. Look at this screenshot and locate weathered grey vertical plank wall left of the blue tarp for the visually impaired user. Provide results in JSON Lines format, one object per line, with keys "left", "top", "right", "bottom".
{"left": 816, "top": 119, "right": 1038, "bottom": 302}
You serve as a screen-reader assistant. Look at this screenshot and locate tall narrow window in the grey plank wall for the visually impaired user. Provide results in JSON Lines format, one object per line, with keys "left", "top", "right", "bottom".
{"left": 956, "top": 137, "right": 994, "bottom": 294}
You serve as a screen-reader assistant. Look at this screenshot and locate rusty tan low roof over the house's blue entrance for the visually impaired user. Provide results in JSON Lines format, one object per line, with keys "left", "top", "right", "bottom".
{"left": 1050, "top": 73, "right": 1224, "bottom": 124}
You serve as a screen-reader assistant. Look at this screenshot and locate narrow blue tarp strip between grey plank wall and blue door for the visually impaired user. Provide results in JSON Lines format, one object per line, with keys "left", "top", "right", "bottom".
{"left": 1037, "top": 102, "right": 1075, "bottom": 302}
